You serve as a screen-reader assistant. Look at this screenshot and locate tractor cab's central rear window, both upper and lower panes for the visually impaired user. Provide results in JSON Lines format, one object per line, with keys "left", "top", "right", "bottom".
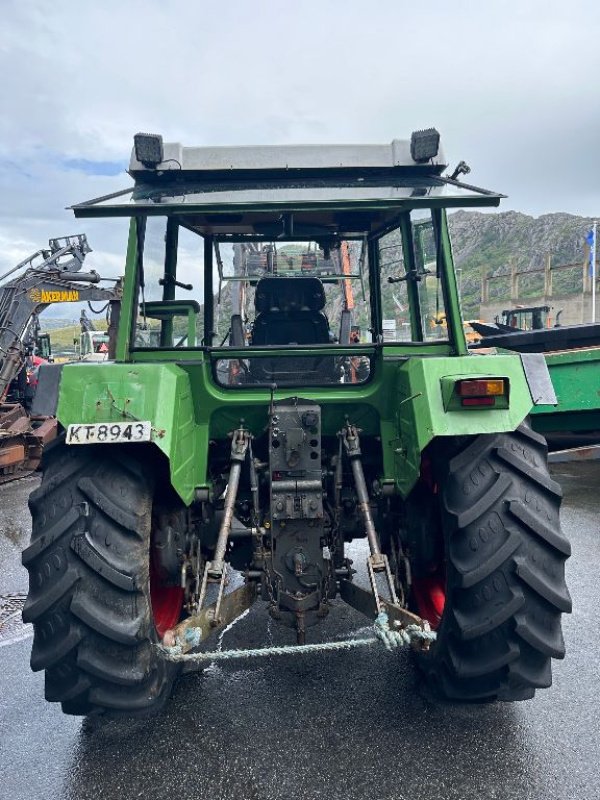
{"left": 213, "top": 240, "right": 371, "bottom": 386}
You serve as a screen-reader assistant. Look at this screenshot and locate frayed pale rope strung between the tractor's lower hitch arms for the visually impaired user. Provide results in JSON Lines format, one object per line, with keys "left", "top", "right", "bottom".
{"left": 157, "top": 611, "right": 436, "bottom": 663}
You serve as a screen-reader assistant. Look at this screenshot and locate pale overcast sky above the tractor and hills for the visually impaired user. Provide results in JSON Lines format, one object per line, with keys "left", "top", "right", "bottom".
{"left": 0, "top": 0, "right": 600, "bottom": 286}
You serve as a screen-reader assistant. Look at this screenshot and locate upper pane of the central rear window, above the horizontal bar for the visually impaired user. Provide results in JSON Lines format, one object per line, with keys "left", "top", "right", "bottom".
{"left": 215, "top": 240, "right": 370, "bottom": 347}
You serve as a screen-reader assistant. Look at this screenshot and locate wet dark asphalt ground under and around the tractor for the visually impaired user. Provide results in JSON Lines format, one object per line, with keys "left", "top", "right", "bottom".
{"left": 0, "top": 462, "right": 600, "bottom": 800}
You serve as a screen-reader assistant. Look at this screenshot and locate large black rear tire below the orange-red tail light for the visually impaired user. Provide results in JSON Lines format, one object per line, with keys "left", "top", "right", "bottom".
{"left": 412, "top": 423, "right": 571, "bottom": 701}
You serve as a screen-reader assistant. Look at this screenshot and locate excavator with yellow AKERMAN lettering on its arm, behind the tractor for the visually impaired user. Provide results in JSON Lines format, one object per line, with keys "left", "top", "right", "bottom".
{"left": 0, "top": 234, "right": 122, "bottom": 483}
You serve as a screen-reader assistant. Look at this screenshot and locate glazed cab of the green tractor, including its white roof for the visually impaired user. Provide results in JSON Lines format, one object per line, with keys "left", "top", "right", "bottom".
{"left": 68, "top": 129, "right": 501, "bottom": 391}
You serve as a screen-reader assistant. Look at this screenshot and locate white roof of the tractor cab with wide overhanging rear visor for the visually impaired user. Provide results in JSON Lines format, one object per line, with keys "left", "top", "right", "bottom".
{"left": 72, "top": 132, "right": 503, "bottom": 239}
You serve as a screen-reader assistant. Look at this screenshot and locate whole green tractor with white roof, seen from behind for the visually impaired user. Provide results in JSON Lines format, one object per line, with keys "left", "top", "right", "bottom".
{"left": 23, "top": 129, "right": 571, "bottom": 714}
